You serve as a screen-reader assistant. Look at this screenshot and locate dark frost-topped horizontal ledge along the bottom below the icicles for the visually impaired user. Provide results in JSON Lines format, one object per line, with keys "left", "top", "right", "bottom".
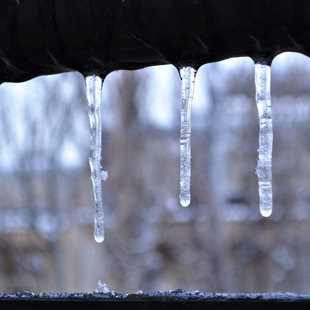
{"left": 0, "top": 290, "right": 310, "bottom": 310}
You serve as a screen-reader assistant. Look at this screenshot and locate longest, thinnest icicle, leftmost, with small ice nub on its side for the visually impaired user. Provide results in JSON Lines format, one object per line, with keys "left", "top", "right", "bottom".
{"left": 85, "top": 75, "right": 107, "bottom": 242}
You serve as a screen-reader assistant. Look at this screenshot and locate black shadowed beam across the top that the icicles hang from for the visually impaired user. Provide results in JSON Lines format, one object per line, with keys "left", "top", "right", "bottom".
{"left": 0, "top": 0, "right": 310, "bottom": 83}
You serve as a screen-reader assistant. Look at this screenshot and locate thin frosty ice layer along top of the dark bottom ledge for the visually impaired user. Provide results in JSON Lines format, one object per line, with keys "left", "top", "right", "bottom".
{"left": 0, "top": 290, "right": 310, "bottom": 302}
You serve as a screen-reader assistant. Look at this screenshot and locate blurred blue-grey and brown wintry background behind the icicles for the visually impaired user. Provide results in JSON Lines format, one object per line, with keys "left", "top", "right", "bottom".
{"left": 0, "top": 53, "right": 310, "bottom": 294}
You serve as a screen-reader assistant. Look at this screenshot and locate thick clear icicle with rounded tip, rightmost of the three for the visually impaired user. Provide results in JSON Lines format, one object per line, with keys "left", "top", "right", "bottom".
{"left": 255, "top": 63, "right": 273, "bottom": 217}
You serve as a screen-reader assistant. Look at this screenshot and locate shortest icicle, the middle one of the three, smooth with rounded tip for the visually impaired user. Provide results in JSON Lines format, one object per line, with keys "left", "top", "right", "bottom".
{"left": 180, "top": 67, "right": 196, "bottom": 207}
